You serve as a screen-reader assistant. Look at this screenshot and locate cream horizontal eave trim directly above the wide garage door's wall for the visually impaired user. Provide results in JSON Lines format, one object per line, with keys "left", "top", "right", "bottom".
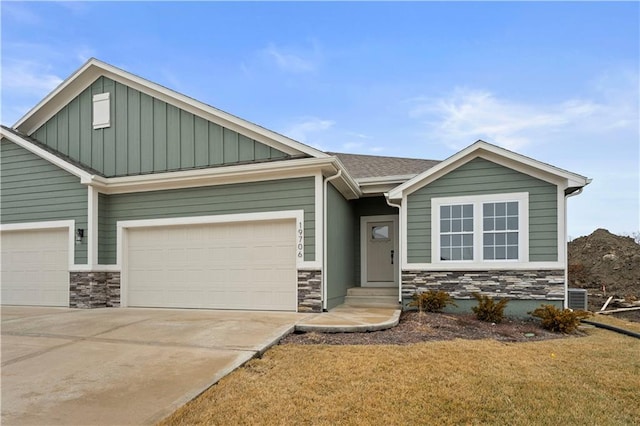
{"left": 91, "top": 158, "right": 340, "bottom": 194}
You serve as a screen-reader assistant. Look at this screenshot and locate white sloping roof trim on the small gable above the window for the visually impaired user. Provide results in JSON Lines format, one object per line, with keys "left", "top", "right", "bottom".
{"left": 389, "top": 141, "right": 591, "bottom": 200}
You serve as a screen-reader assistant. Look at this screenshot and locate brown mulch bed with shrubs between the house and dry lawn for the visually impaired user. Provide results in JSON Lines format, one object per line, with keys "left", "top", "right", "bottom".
{"left": 280, "top": 311, "right": 586, "bottom": 345}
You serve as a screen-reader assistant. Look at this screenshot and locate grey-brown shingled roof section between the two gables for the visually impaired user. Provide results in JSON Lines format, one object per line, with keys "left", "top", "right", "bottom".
{"left": 327, "top": 152, "right": 440, "bottom": 179}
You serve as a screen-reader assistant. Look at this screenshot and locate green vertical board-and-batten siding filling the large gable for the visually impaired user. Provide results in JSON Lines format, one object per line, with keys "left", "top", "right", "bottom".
{"left": 30, "top": 77, "right": 287, "bottom": 177}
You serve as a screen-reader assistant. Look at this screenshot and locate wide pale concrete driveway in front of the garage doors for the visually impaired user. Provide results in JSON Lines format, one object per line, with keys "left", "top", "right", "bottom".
{"left": 2, "top": 306, "right": 308, "bottom": 425}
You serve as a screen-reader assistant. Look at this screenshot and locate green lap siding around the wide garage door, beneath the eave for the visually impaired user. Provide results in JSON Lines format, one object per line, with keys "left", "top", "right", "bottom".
{"left": 98, "top": 177, "right": 315, "bottom": 264}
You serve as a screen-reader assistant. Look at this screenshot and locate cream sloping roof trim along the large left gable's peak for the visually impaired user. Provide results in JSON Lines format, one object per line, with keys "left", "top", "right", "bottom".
{"left": 13, "top": 58, "right": 329, "bottom": 158}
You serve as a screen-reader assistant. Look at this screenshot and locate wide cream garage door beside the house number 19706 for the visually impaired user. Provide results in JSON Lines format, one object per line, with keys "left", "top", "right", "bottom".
{"left": 126, "top": 220, "right": 297, "bottom": 311}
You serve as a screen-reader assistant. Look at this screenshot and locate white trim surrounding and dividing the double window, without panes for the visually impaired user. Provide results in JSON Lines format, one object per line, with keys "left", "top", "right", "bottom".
{"left": 431, "top": 192, "right": 529, "bottom": 269}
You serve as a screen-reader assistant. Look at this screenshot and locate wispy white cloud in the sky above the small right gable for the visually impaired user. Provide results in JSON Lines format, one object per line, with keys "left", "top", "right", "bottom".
{"left": 409, "top": 73, "right": 638, "bottom": 150}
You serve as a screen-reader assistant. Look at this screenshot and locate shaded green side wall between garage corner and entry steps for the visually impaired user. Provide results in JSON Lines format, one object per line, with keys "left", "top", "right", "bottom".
{"left": 326, "top": 184, "right": 357, "bottom": 309}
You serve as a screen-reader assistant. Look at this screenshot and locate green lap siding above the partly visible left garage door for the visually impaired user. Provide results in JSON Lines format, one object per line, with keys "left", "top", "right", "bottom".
{"left": 0, "top": 139, "right": 87, "bottom": 265}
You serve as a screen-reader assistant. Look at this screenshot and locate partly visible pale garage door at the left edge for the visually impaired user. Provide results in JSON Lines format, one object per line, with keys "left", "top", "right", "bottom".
{"left": 0, "top": 229, "right": 69, "bottom": 306}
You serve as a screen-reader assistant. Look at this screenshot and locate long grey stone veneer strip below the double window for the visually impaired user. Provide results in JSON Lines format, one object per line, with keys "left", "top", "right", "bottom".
{"left": 402, "top": 269, "right": 564, "bottom": 301}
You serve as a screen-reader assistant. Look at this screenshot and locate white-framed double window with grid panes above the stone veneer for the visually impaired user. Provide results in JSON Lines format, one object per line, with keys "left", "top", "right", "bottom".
{"left": 431, "top": 192, "right": 529, "bottom": 264}
